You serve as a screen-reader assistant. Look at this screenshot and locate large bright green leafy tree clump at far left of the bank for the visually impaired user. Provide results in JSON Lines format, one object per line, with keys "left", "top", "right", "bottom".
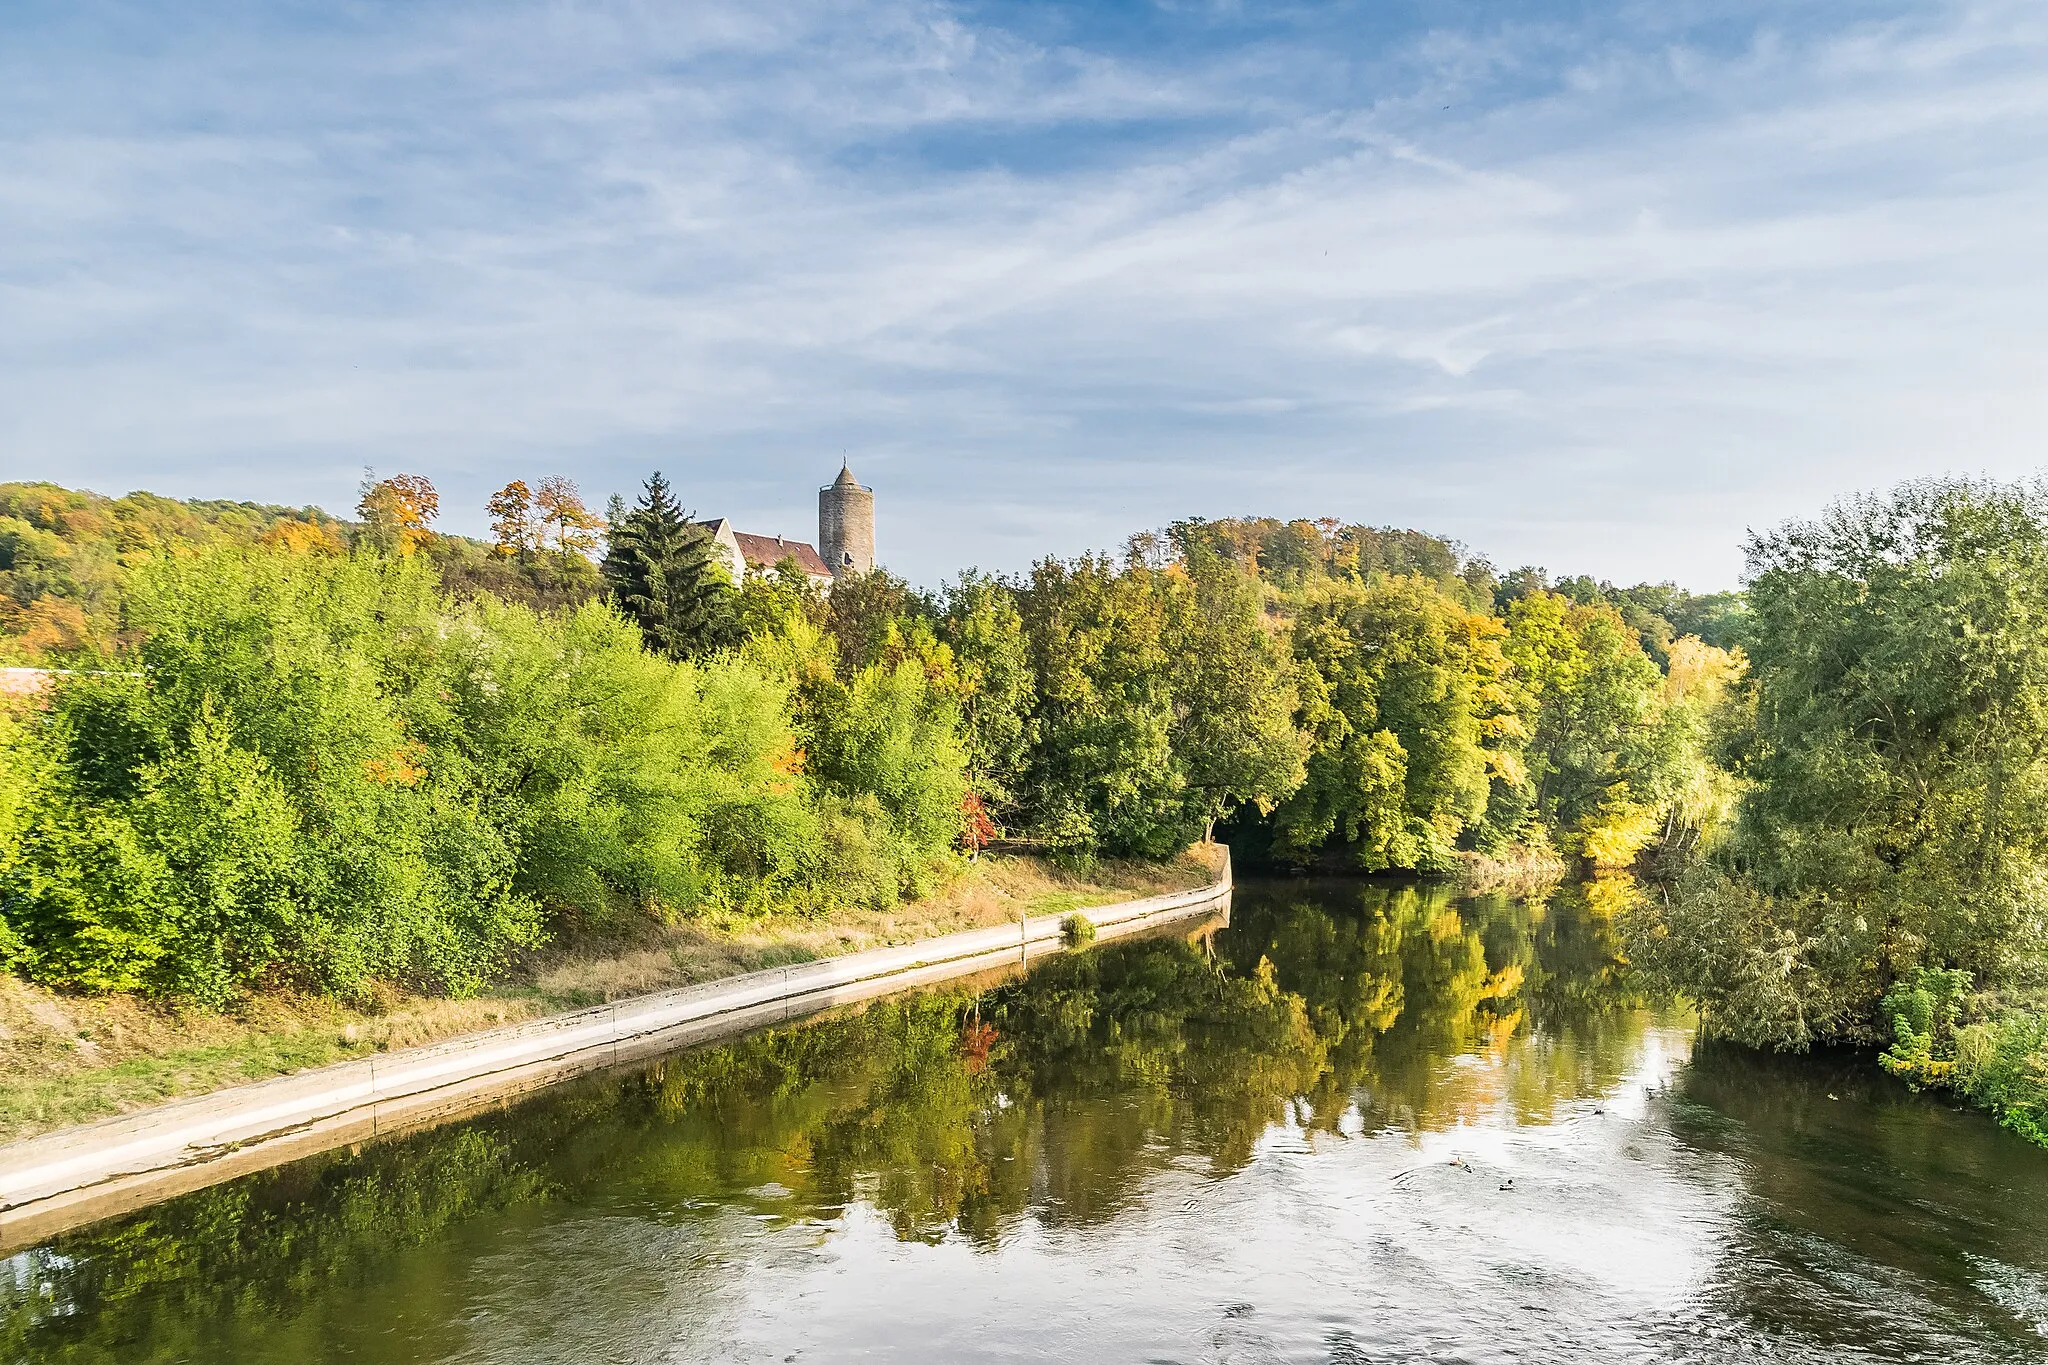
{"left": 0, "top": 548, "right": 541, "bottom": 1003}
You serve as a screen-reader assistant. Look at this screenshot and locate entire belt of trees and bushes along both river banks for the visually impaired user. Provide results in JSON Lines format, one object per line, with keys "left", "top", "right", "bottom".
{"left": 0, "top": 475, "right": 2048, "bottom": 1140}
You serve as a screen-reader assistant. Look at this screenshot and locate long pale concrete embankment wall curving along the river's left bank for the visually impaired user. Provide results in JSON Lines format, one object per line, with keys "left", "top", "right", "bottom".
{"left": 0, "top": 853, "right": 1231, "bottom": 1250}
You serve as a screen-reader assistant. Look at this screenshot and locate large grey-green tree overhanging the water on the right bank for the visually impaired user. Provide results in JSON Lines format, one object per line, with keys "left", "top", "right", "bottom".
{"left": 1645, "top": 479, "right": 2048, "bottom": 1048}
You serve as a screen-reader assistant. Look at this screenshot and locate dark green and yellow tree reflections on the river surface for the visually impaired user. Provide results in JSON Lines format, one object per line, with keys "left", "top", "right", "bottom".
{"left": 0, "top": 882, "right": 1645, "bottom": 1361}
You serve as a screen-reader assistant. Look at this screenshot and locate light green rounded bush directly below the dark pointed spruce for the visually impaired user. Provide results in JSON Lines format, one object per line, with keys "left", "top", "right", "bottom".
{"left": 420, "top": 600, "right": 821, "bottom": 919}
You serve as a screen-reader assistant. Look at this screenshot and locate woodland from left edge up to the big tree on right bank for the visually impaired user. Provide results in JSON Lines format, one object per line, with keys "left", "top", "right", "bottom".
{"left": 0, "top": 475, "right": 1737, "bottom": 1003}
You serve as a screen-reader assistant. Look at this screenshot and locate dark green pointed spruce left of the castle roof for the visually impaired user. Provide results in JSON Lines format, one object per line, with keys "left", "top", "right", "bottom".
{"left": 604, "top": 471, "right": 733, "bottom": 659}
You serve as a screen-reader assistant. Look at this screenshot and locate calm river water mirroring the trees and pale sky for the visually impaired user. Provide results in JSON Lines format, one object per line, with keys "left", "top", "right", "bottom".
{"left": 0, "top": 882, "right": 2048, "bottom": 1365}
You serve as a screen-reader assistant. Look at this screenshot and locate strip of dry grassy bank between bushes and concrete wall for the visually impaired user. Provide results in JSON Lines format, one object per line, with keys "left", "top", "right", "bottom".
{"left": 0, "top": 849, "right": 1212, "bottom": 1142}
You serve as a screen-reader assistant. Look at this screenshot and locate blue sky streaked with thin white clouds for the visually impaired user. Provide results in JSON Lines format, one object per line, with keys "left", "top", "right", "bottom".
{"left": 0, "top": 0, "right": 2048, "bottom": 591}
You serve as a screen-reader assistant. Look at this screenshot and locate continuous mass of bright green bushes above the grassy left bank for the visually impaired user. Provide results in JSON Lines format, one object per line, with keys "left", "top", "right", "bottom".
{"left": 0, "top": 548, "right": 983, "bottom": 1003}
